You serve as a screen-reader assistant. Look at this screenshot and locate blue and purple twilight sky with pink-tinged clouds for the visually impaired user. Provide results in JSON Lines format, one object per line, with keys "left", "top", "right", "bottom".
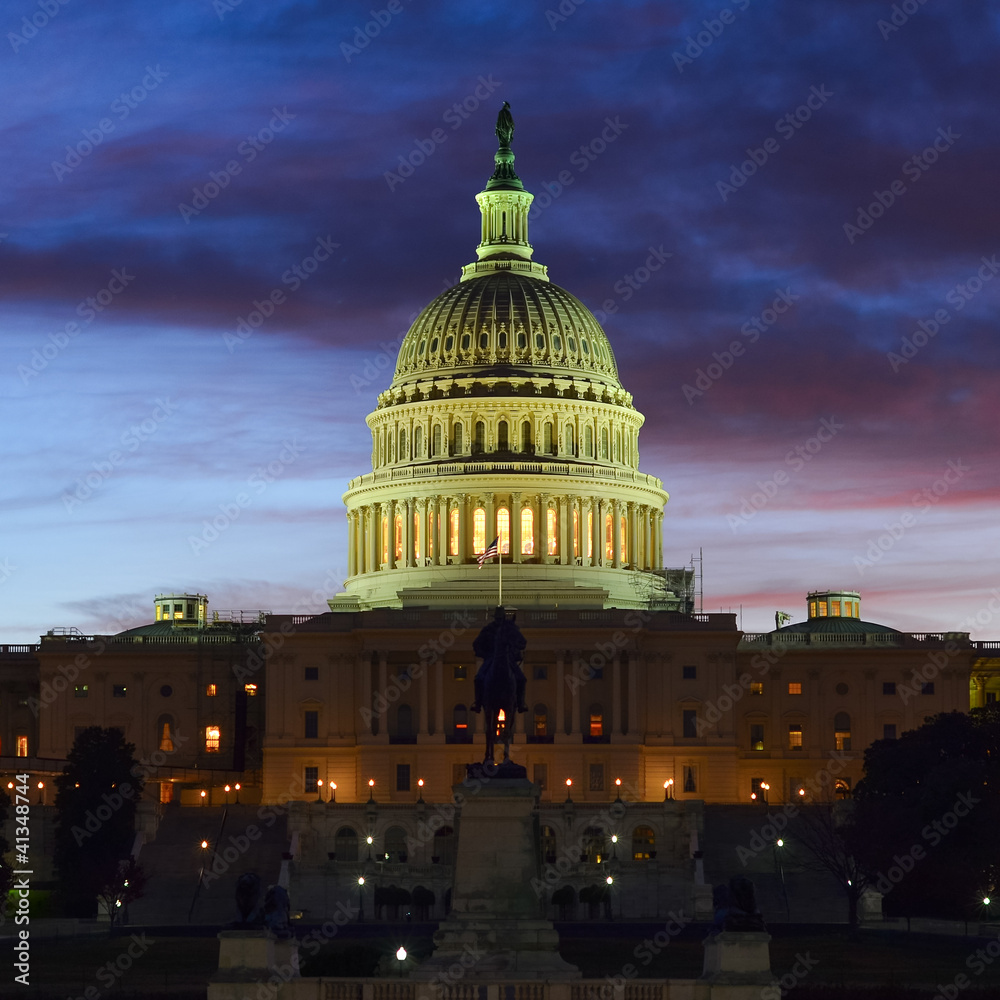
{"left": 0, "top": 0, "right": 1000, "bottom": 643}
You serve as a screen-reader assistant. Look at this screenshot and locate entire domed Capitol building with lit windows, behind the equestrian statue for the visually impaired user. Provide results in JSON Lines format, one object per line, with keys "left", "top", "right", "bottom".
{"left": 0, "top": 113, "right": 1000, "bottom": 916}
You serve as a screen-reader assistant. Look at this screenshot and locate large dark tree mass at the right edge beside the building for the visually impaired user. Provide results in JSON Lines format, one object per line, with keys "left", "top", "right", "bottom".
{"left": 855, "top": 705, "right": 1000, "bottom": 919}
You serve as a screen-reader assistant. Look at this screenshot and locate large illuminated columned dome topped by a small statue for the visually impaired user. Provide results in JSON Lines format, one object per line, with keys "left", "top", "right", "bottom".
{"left": 330, "top": 105, "right": 684, "bottom": 611}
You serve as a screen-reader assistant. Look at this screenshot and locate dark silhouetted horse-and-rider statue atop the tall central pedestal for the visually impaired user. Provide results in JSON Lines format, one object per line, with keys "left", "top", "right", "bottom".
{"left": 472, "top": 608, "right": 527, "bottom": 763}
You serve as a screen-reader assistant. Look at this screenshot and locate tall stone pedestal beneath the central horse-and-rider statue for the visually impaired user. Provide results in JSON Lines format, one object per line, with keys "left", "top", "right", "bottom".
{"left": 413, "top": 770, "right": 580, "bottom": 985}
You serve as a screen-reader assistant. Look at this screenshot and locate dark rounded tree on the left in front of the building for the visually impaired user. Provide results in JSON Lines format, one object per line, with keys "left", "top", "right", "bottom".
{"left": 54, "top": 726, "right": 143, "bottom": 917}
